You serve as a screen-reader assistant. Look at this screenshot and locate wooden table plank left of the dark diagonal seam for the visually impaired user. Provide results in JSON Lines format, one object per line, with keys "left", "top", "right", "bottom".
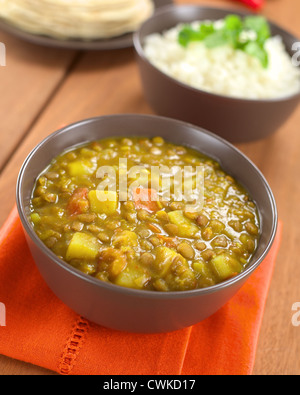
{"left": 0, "top": 32, "right": 76, "bottom": 171}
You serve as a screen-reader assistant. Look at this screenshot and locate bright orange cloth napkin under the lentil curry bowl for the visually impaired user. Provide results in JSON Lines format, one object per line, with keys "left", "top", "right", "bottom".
{"left": 0, "top": 208, "right": 282, "bottom": 375}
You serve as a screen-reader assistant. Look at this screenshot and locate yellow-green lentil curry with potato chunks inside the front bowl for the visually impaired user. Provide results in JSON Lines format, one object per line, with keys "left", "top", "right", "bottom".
{"left": 30, "top": 137, "right": 259, "bottom": 291}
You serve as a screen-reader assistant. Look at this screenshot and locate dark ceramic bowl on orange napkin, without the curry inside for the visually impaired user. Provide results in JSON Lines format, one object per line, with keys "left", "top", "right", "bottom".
{"left": 16, "top": 114, "right": 277, "bottom": 333}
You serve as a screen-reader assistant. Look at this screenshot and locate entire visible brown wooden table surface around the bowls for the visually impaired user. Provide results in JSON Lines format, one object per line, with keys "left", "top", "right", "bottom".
{"left": 0, "top": 0, "right": 300, "bottom": 375}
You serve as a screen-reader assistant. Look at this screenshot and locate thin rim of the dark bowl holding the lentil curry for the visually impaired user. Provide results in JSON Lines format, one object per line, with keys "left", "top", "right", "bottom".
{"left": 16, "top": 113, "right": 278, "bottom": 299}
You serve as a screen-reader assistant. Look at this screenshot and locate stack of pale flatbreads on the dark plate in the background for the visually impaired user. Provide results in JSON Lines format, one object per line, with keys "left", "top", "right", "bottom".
{"left": 0, "top": 0, "right": 154, "bottom": 40}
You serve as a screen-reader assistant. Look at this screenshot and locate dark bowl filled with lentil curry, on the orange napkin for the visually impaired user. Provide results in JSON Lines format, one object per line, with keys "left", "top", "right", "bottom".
{"left": 17, "top": 114, "right": 277, "bottom": 333}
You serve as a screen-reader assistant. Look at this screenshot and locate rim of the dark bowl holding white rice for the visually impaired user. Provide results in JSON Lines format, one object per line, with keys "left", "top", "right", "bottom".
{"left": 133, "top": 4, "right": 300, "bottom": 104}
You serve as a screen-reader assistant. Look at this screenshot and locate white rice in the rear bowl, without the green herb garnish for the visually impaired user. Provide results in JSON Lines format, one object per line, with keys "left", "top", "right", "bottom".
{"left": 144, "top": 22, "right": 300, "bottom": 99}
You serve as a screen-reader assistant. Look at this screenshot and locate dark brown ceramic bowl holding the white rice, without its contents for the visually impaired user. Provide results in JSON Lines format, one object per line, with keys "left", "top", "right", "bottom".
{"left": 134, "top": 5, "right": 300, "bottom": 143}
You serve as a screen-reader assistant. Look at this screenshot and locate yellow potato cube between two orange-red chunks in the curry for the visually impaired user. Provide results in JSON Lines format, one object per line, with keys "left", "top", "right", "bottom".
{"left": 88, "top": 190, "right": 118, "bottom": 215}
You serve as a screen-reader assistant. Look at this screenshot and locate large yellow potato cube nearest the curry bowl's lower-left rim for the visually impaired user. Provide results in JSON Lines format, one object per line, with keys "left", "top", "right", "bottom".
{"left": 66, "top": 232, "right": 100, "bottom": 261}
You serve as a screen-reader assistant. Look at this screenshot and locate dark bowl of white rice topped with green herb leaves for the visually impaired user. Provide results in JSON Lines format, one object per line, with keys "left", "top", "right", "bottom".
{"left": 134, "top": 5, "right": 300, "bottom": 143}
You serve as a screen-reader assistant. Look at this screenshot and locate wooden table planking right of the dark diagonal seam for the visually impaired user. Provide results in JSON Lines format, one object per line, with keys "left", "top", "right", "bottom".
{"left": 0, "top": 0, "right": 300, "bottom": 374}
